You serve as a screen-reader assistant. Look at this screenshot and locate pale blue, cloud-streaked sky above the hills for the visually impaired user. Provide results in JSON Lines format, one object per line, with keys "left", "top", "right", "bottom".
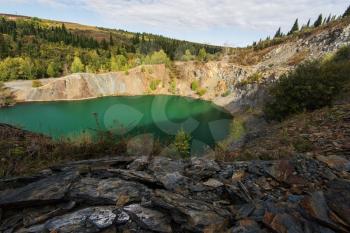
{"left": 0, "top": 0, "right": 350, "bottom": 46}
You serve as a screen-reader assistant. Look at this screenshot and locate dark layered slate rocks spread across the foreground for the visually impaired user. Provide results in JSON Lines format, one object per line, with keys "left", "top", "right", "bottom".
{"left": 0, "top": 155, "right": 350, "bottom": 233}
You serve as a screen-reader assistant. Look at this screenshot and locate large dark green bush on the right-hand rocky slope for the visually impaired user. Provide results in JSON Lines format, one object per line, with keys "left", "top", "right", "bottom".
{"left": 264, "top": 47, "right": 350, "bottom": 121}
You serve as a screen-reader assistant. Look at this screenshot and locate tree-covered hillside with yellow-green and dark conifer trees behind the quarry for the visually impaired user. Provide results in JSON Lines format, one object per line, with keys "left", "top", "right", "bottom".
{"left": 0, "top": 16, "right": 221, "bottom": 81}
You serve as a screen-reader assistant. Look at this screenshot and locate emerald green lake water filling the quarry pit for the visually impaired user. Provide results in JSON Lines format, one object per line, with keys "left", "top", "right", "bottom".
{"left": 0, "top": 96, "right": 232, "bottom": 156}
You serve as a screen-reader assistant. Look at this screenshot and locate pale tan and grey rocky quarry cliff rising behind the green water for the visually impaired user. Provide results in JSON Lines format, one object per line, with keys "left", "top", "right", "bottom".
{"left": 6, "top": 20, "right": 350, "bottom": 113}
